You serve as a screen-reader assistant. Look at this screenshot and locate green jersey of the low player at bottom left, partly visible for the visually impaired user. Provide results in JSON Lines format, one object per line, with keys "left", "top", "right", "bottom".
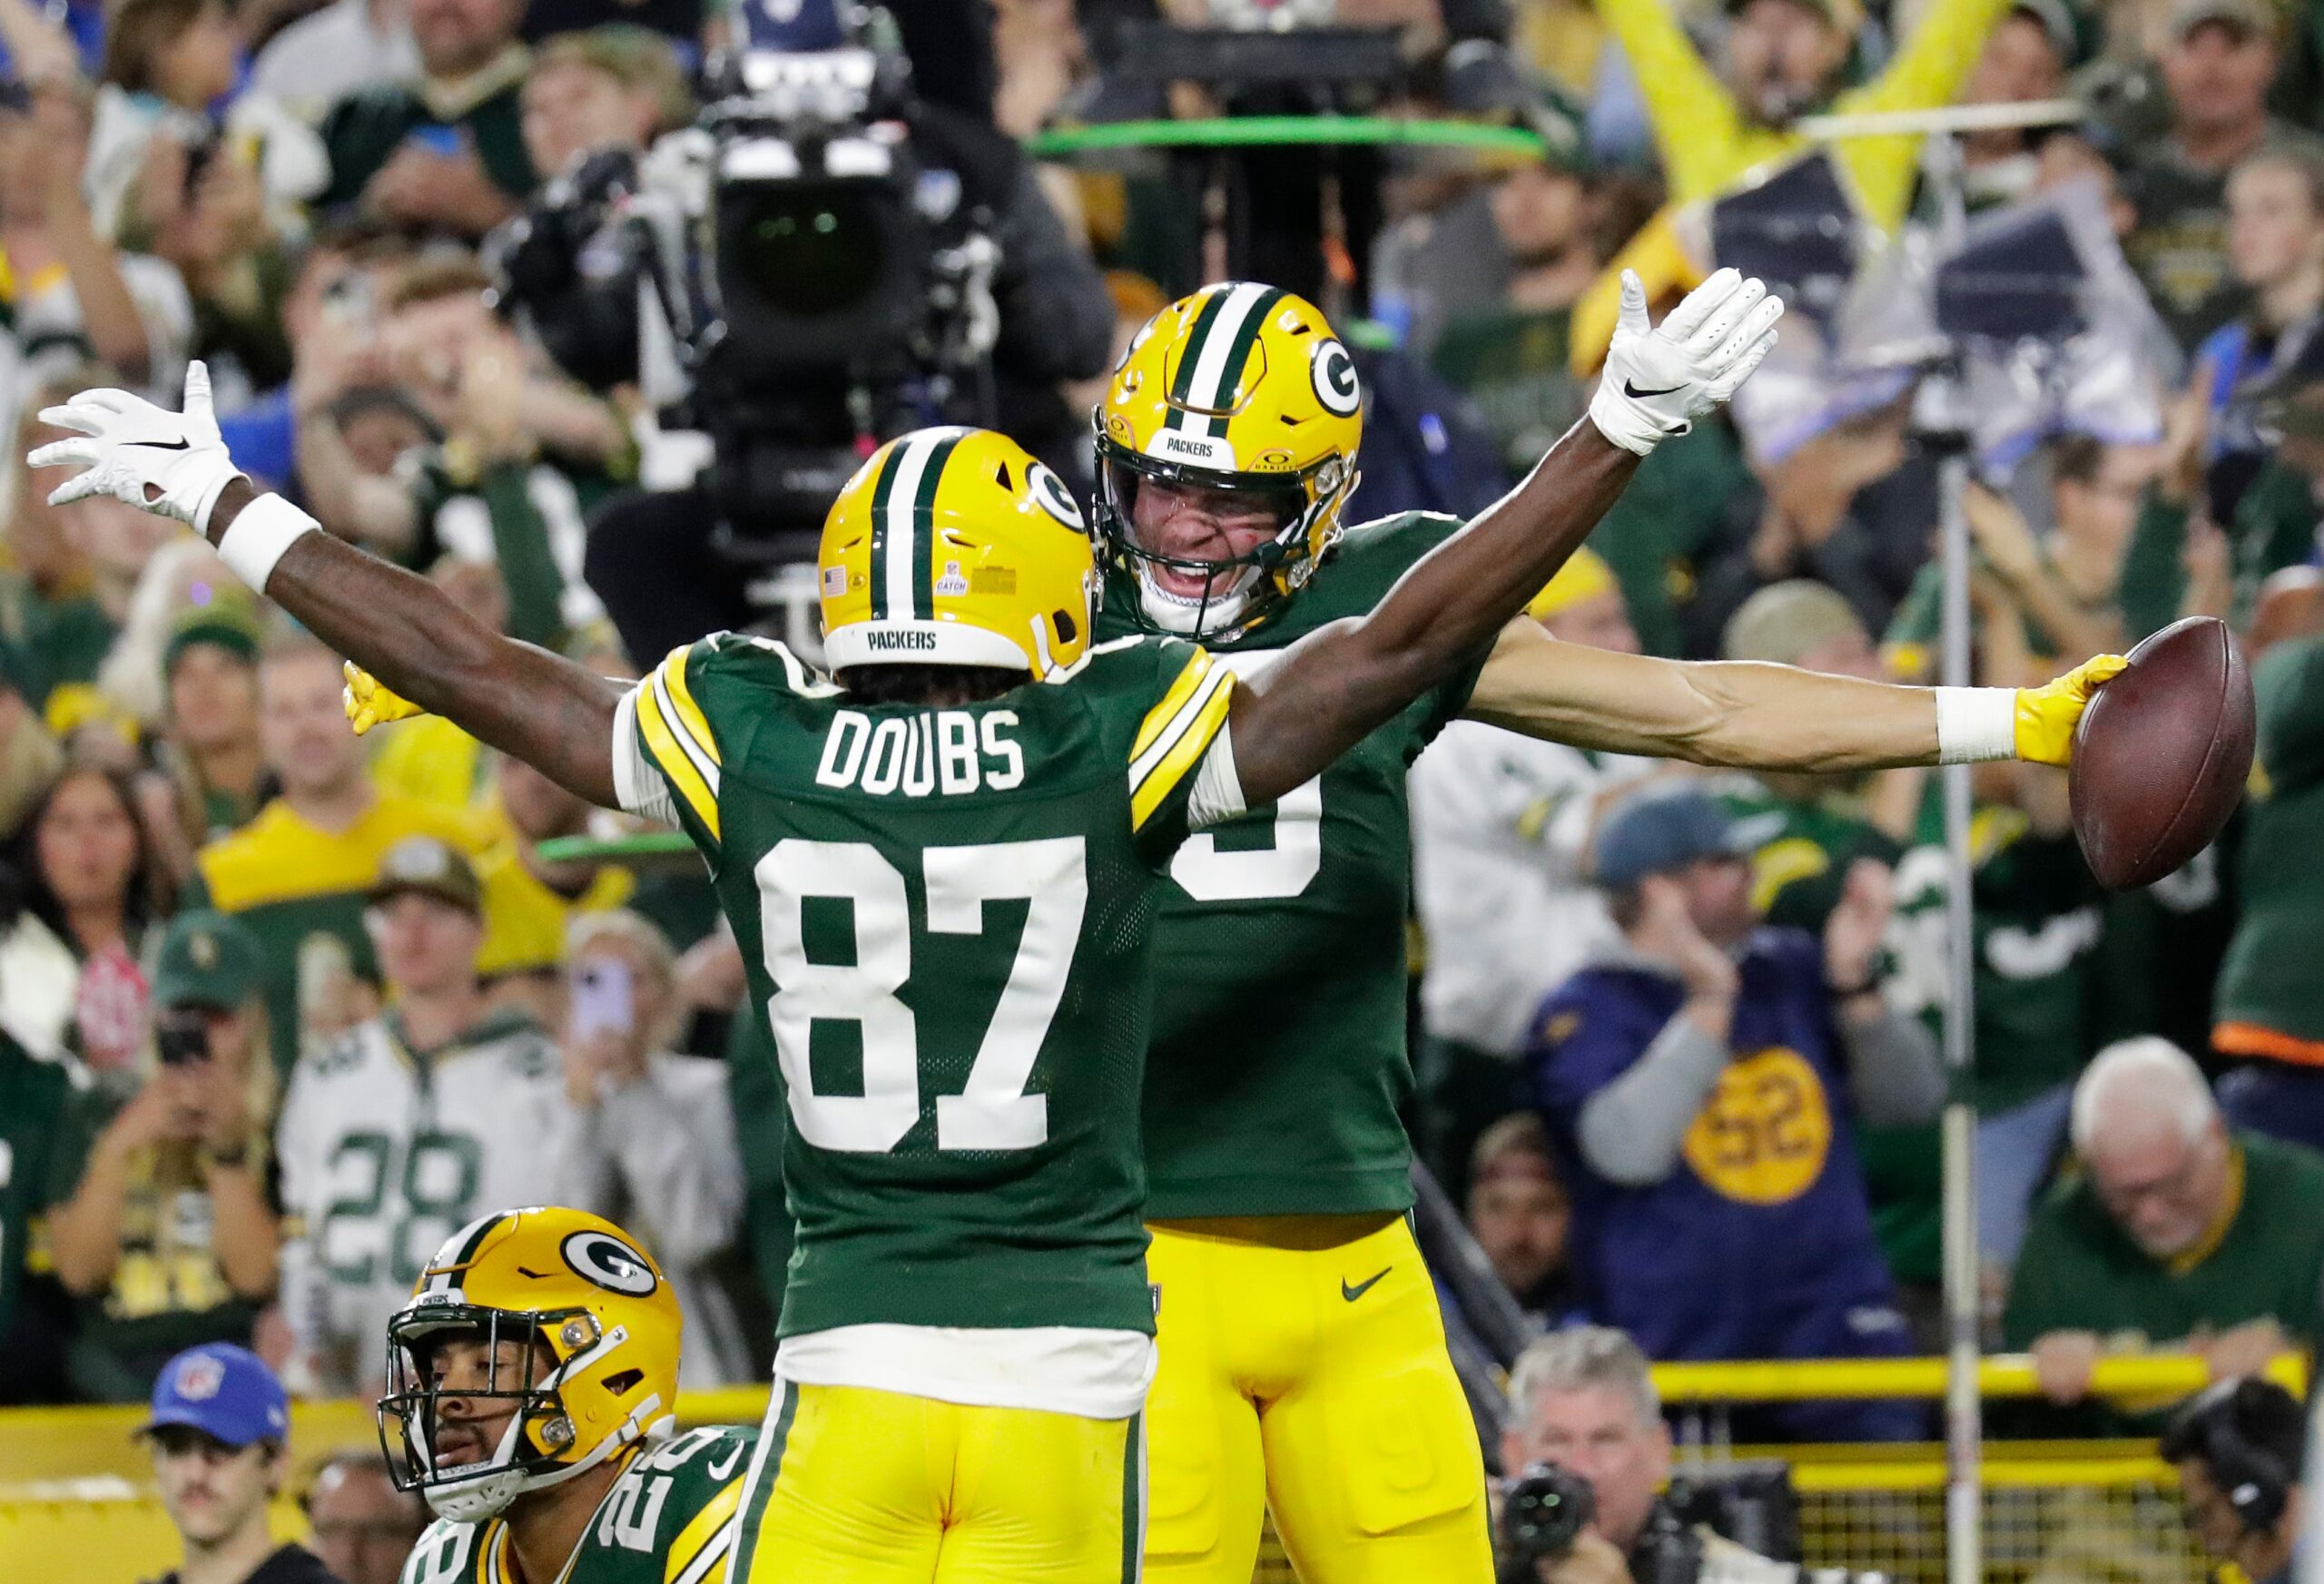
{"left": 402, "top": 1423, "right": 758, "bottom": 1584}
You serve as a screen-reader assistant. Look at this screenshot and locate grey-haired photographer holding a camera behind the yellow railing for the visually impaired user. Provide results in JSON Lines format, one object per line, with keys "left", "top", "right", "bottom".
{"left": 1494, "top": 1326, "right": 1798, "bottom": 1584}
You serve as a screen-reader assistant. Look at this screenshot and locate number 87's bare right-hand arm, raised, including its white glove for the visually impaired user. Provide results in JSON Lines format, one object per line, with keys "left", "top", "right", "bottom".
{"left": 1229, "top": 270, "right": 1783, "bottom": 803}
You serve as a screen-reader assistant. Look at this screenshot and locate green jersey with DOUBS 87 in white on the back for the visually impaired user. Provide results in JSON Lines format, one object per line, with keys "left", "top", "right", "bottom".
{"left": 615, "top": 635, "right": 1232, "bottom": 1335}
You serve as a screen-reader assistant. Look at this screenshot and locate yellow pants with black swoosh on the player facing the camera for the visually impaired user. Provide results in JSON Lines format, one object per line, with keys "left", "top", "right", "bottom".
{"left": 1146, "top": 1215, "right": 1492, "bottom": 1584}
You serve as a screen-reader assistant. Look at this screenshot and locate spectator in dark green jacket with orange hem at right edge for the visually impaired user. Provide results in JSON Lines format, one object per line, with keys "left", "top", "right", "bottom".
{"left": 2211, "top": 636, "right": 2324, "bottom": 1150}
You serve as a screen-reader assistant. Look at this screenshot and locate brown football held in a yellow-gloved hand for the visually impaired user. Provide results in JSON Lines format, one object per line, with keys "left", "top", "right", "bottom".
{"left": 2066, "top": 615, "right": 2254, "bottom": 892}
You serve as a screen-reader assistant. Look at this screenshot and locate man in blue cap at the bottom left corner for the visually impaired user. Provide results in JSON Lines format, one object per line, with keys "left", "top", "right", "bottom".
{"left": 140, "top": 1343, "right": 340, "bottom": 1584}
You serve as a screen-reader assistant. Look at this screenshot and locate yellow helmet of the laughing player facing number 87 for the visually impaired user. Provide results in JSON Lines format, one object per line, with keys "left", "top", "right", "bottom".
{"left": 1095, "top": 281, "right": 1364, "bottom": 639}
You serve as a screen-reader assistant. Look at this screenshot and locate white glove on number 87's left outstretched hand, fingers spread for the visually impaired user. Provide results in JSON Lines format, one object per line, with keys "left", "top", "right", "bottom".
{"left": 25, "top": 362, "right": 240, "bottom": 532}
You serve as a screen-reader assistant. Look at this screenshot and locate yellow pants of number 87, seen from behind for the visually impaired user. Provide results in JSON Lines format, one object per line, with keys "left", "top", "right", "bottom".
{"left": 732, "top": 1380, "right": 1146, "bottom": 1584}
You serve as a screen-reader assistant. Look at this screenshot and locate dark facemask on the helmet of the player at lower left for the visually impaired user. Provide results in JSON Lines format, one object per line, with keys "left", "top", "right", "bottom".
{"left": 379, "top": 1303, "right": 669, "bottom": 1523}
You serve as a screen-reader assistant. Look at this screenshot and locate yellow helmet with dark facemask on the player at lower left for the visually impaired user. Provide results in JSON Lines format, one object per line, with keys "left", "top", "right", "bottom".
{"left": 379, "top": 1205, "right": 684, "bottom": 1523}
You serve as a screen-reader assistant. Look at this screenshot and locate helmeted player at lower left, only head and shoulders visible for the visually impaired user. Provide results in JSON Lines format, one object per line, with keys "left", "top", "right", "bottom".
{"left": 379, "top": 1207, "right": 758, "bottom": 1584}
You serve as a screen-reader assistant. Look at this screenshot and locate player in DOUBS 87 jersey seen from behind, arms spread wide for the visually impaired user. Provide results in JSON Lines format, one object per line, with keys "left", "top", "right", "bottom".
{"left": 33, "top": 271, "right": 1775, "bottom": 1584}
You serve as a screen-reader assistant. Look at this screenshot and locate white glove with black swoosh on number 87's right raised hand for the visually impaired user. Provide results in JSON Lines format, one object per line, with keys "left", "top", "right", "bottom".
{"left": 1590, "top": 270, "right": 1783, "bottom": 457}
